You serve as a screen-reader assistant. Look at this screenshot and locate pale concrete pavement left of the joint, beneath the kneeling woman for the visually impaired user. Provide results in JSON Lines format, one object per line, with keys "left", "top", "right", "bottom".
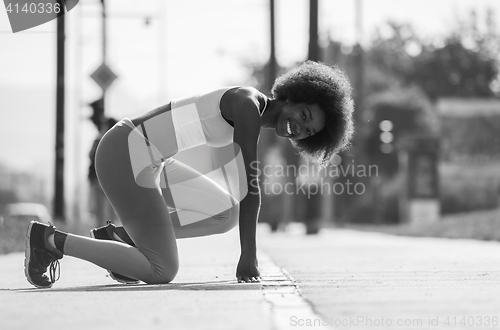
{"left": 0, "top": 230, "right": 273, "bottom": 330}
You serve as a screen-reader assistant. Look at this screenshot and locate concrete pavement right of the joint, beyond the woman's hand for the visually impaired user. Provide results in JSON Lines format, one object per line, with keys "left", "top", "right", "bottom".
{"left": 259, "top": 224, "right": 500, "bottom": 329}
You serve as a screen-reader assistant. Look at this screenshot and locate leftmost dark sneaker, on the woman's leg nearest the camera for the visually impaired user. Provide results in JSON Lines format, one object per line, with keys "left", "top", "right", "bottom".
{"left": 24, "top": 221, "right": 63, "bottom": 288}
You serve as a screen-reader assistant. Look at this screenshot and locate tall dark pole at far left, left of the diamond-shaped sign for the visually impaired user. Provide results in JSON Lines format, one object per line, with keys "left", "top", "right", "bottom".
{"left": 54, "top": 0, "right": 65, "bottom": 221}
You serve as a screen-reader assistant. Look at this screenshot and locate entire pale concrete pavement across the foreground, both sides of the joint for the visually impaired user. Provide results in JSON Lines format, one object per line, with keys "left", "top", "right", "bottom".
{"left": 0, "top": 225, "right": 500, "bottom": 330}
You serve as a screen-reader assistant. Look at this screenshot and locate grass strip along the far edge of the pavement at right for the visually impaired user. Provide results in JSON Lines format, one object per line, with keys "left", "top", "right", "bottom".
{"left": 345, "top": 208, "right": 500, "bottom": 241}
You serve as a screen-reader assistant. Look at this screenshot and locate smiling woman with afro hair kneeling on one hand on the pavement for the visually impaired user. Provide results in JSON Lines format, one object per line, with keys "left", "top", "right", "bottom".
{"left": 25, "top": 61, "right": 353, "bottom": 288}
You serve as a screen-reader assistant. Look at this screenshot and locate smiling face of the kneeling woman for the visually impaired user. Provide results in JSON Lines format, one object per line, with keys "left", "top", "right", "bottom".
{"left": 275, "top": 103, "right": 325, "bottom": 140}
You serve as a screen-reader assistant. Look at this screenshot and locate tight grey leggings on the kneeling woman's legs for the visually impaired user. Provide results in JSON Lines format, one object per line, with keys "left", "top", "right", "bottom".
{"left": 64, "top": 119, "right": 239, "bottom": 283}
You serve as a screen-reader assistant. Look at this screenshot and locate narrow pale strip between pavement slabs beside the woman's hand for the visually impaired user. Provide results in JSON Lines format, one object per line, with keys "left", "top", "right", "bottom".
{"left": 258, "top": 252, "right": 332, "bottom": 330}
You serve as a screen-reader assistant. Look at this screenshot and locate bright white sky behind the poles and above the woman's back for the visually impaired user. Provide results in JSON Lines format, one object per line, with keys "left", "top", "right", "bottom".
{"left": 0, "top": 0, "right": 500, "bottom": 214}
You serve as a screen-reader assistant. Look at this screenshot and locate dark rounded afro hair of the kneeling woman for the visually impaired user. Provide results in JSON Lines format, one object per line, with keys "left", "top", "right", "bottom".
{"left": 271, "top": 61, "right": 354, "bottom": 167}
